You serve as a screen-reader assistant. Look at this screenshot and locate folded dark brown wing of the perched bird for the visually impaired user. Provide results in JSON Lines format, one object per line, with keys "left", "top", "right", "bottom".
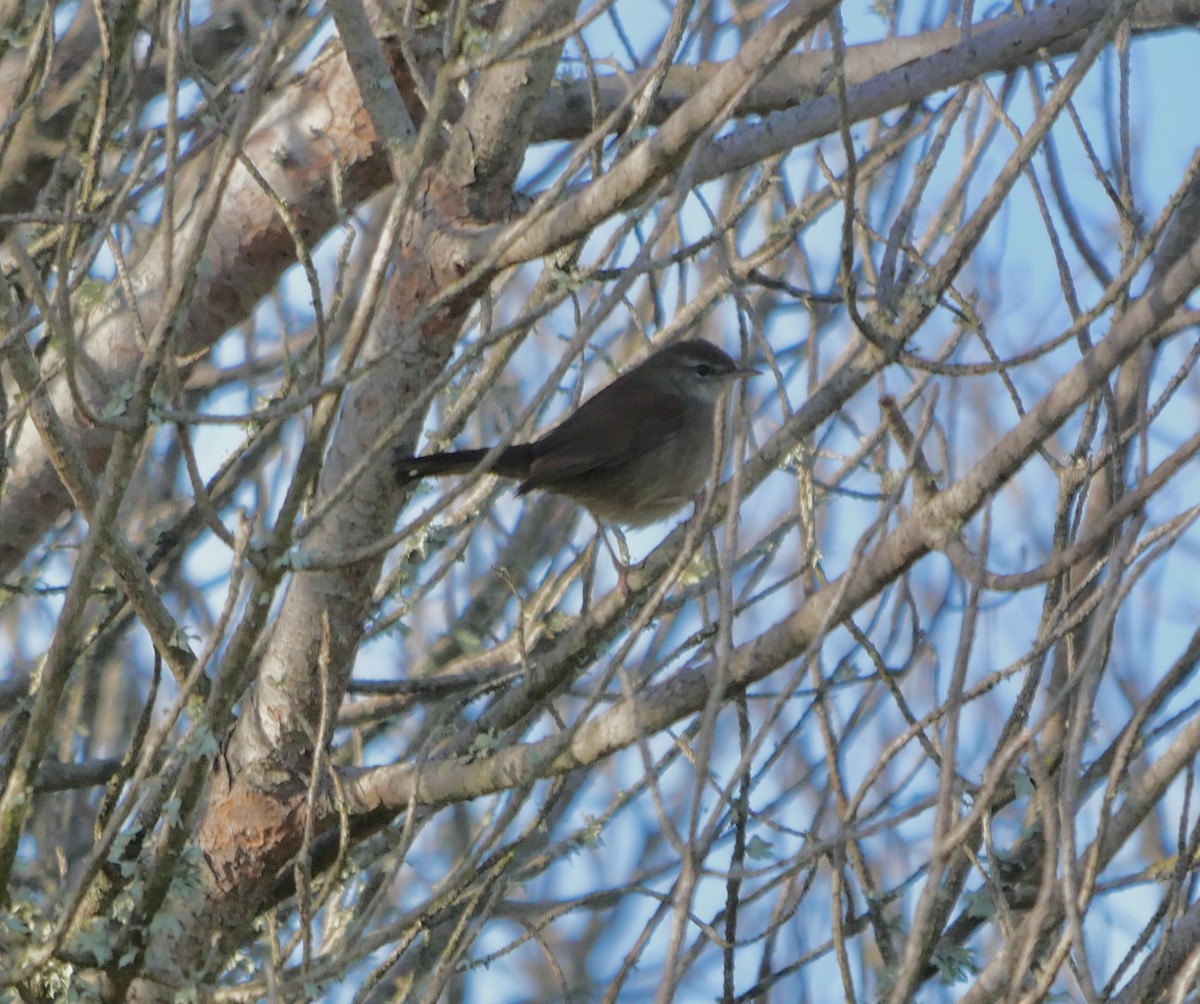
{"left": 518, "top": 385, "right": 684, "bottom": 494}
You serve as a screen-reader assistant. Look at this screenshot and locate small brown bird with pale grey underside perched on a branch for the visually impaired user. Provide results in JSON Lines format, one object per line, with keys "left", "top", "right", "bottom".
{"left": 396, "top": 338, "right": 758, "bottom": 528}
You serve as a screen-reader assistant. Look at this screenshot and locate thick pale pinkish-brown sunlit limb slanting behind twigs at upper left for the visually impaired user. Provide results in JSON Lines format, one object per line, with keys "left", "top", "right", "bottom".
{"left": 0, "top": 50, "right": 388, "bottom": 575}
